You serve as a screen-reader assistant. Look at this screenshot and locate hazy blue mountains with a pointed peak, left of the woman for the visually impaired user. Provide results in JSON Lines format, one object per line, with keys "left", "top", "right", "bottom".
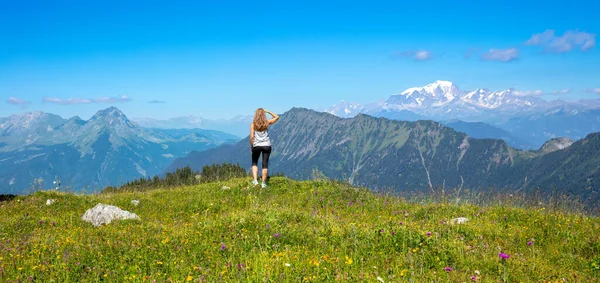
{"left": 0, "top": 107, "right": 238, "bottom": 194}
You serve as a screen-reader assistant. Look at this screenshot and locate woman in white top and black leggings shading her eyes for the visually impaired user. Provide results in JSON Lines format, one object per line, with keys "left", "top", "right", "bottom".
{"left": 250, "top": 108, "right": 279, "bottom": 188}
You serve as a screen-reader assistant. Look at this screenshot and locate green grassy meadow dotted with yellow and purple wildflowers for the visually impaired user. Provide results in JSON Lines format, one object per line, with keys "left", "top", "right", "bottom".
{"left": 0, "top": 177, "right": 600, "bottom": 282}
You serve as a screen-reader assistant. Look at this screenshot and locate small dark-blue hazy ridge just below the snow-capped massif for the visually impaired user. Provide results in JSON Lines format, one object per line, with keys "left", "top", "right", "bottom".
{"left": 441, "top": 120, "right": 539, "bottom": 149}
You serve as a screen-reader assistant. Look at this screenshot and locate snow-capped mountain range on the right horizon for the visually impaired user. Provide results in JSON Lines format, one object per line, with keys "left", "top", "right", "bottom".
{"left": 326, "top": 80, "right": 600, "bottom": 149}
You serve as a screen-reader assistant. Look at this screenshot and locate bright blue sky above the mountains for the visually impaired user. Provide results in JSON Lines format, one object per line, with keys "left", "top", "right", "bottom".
{"left": 0, "top": 0, "right": 600, "bottom": 119}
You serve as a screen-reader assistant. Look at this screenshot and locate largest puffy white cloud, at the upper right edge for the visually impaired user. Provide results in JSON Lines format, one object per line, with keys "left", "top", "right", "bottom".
{"left": 525, "top": 30, "right": 596, "bottom": 53}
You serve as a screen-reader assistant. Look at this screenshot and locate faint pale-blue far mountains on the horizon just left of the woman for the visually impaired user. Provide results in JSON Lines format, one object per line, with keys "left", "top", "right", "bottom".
{"left": 132, "top": 115, "right": 253, "bottom": 137}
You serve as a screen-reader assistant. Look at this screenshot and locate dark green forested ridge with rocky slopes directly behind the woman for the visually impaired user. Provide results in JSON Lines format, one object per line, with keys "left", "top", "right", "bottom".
{"left": 168, "top": 108, "right": 600, "bottom": 207}
